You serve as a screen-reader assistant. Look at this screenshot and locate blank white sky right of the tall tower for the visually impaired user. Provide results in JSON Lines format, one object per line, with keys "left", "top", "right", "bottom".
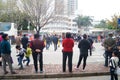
{"left": 77, "top": 0, "right": 120, "bottom": 21}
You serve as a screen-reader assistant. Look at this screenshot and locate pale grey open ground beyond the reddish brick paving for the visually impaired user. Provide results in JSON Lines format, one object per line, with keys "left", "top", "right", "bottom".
{"left": 12, "top": 43, "right": 104, "bottom": 66}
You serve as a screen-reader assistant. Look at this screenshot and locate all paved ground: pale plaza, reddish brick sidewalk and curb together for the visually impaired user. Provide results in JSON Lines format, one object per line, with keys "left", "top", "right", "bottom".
{"left": 0, "top": 43, "right": 109, "bottom": 79}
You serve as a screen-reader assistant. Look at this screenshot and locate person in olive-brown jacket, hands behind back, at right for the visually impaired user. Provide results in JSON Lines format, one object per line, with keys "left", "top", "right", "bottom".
{"left": 103, "top": 32, "right": 116, "bottom": 67}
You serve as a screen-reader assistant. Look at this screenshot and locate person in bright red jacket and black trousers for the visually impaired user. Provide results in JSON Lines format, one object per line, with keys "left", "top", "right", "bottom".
{"left": 62, "top": 33, "right": 74, "bottom": 72}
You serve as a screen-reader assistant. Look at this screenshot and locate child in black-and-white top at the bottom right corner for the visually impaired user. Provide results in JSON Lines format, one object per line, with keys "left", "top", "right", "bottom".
{"left": 109, "top": 50, "right": 119, "bottom": 80}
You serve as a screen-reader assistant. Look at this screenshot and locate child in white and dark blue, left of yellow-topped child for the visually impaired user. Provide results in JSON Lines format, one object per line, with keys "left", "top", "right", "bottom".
{"left": 16, "top": 46, "right": 26, "bottom": 69}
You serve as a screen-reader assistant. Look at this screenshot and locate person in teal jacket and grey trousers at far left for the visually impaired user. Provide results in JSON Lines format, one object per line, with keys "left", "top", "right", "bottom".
{"left": 0, "top": 34, "right": 16, "bottom": 74}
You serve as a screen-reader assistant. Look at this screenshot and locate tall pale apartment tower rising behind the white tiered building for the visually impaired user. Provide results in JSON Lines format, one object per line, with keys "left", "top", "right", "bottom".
{"left": 55, "top": 0, "right": 78, "bottom": 16}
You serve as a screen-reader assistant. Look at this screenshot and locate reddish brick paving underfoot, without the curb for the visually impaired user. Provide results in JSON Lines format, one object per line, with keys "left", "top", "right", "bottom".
{"left": 0, "top": 63, "right": 109, "bottom": 75}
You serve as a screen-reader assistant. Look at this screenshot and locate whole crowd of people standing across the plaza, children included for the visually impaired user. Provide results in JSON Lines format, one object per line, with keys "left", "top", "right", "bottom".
{"left": 0, "top": 33, "right": 120, "bottom": 80}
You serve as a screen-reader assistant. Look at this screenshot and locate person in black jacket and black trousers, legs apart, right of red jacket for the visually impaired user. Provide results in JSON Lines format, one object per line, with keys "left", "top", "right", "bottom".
{"left": 77, "top": 34, "right": 92, "bottom": 71}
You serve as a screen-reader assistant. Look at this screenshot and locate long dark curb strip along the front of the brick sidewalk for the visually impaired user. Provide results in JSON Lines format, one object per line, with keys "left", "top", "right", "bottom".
{"left": 0, "top": 72, "right": 109, "bottom": 80}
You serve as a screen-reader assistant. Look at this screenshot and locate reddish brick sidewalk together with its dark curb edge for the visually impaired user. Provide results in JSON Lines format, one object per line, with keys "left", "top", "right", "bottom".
{"left": 0, "top": 63, "right": 109, "bottom": 79}
